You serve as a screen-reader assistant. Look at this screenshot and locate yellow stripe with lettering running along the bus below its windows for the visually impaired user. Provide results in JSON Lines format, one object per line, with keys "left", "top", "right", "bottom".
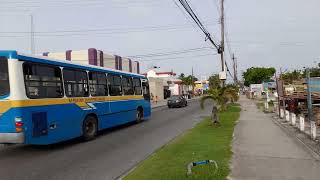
{"left": 0, "top": 95, "right": 143, "bottom": 114}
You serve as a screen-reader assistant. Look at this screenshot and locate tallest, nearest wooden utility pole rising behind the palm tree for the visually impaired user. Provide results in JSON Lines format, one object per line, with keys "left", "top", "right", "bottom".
{"left": 219, "top": 0, "right": 226, "bottom": 87}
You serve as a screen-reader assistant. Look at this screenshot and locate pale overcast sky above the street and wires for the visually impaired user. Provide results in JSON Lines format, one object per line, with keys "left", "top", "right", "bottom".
{"left": 0, "top": 0, "right": 320, "bottom": 78}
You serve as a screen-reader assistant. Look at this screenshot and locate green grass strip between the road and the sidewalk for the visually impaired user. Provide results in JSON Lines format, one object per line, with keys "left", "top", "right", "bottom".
{"left": 124, "top": 104, "right": 240, "bottom": 180}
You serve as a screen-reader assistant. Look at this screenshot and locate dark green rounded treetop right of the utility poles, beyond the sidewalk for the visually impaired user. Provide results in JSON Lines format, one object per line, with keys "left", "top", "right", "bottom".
{"left": 242, "top": 67, "right": 276, "bottom": 86}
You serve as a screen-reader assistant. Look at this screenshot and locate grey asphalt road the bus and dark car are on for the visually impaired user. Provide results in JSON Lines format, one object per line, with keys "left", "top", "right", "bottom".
{"left": 0, "top": 101, "right": 210, "bottom": 180}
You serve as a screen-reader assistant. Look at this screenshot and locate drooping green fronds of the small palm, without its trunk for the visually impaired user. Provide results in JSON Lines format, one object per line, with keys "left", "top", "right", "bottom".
{"left": 200, "top": 85, "right": 239, "bottom": 112}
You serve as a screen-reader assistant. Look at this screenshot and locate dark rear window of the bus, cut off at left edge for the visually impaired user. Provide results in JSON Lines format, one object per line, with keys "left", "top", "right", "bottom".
{"left": 0, "top": 57, "right": 10, "bottom": 96}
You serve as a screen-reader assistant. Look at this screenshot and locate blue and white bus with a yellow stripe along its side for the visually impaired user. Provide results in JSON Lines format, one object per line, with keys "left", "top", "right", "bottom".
{"left": 0, "top": 51, "right": 151, "bottom": 145}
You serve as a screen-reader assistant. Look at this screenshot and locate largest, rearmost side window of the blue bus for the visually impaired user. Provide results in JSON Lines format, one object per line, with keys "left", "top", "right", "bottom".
{"left": 23, "top": 63, "right": 63, "bottom": 99}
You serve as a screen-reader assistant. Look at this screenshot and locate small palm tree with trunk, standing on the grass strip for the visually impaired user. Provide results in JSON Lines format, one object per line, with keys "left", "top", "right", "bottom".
{"left": 200, "top": 85, "right": 239, "bottom": 125}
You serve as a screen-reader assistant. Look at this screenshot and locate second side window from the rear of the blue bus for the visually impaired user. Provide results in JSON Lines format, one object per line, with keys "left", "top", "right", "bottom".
{"left": 63, "top": 69, "right": 89, "bottom": 97}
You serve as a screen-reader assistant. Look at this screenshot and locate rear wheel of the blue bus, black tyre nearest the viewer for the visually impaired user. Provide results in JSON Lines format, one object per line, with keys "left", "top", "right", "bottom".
{"left": 83, "top": 116, "right": 98, "bottom": 141}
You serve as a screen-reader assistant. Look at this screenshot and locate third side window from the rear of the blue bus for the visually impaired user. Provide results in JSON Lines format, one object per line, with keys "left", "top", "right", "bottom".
{"left": 89, "top": 72, "right": 108, "bottom": 96}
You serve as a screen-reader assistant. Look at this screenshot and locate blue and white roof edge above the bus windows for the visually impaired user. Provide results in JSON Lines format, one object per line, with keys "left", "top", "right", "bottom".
{"left": 0, "top": 50, "right": 145, "bottom": 78}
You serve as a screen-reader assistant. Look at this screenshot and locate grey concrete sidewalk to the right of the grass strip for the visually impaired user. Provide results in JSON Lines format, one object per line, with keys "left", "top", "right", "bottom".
{"left": 230, "top": 96, "right": 320, "bottom": 180}
